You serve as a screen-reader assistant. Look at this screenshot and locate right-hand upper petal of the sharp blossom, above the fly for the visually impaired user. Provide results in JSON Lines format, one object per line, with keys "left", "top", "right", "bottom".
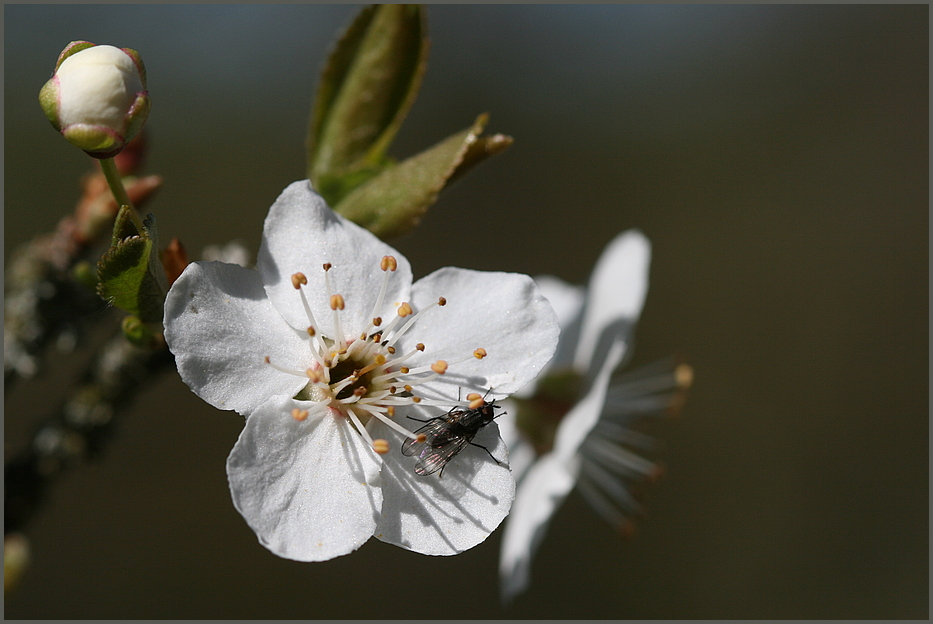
{"left": 399, "top": 267, "right": 560, "bottom": 398}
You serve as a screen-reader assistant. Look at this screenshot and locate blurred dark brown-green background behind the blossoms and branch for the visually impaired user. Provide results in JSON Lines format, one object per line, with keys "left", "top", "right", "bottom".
{"left": 4, "top": 5, "right": 929, "bottom": 619}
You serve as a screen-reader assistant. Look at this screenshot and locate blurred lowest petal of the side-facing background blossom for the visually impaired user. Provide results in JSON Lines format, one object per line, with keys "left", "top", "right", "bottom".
{"left": 499, "top": 453, "right": 579, "bottom": 601}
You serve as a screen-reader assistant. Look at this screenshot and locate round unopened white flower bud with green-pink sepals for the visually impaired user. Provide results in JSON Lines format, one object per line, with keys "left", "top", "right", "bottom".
{"left": 39, "top": 41, "right": 149, "bottom": 158}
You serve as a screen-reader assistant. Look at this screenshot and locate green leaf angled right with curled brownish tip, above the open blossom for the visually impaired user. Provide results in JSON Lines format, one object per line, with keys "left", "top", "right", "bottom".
{"left": 334, "top": 114, "right": 512, "bottom": 239}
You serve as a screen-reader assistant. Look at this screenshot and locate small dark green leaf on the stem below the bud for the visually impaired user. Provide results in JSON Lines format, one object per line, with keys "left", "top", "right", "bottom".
{"left": 97, "top": 206, "right": 168, "bottom": 325}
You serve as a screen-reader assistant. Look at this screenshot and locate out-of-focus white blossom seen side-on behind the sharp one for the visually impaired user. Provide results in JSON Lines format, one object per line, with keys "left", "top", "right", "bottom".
{"left": 499, "top": 230, "right": 690, "bottom": 601}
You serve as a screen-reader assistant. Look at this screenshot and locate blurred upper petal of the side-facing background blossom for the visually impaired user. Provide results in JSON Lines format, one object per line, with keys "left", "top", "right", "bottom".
{"left": 574, "top": 230, "right": 651, "bottom": 371}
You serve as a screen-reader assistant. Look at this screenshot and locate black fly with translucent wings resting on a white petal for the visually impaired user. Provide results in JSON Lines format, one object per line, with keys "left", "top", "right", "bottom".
{"left": 402, "top": 394, "right": 502, "bottom": 477}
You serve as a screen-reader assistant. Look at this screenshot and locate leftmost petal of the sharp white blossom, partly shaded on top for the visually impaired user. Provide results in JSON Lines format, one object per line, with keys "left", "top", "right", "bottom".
{"left": 165, "top": 262, "right": 311, "bottom": 415}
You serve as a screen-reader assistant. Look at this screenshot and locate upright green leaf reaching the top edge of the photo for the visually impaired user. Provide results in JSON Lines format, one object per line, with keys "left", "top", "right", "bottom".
{"left": 307, "top": 4, "right": 428, "bottom": 205}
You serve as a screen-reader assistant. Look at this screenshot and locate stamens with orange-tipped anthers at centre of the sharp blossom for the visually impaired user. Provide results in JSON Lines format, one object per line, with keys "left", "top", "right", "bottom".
{"left": 266, "top": 256, "right": 486, "bottom": 453}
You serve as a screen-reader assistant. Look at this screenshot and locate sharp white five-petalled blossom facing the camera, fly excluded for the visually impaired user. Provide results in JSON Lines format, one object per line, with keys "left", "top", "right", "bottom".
{"left": 165, "top": 181, "right": 558, "bottom": 561}
